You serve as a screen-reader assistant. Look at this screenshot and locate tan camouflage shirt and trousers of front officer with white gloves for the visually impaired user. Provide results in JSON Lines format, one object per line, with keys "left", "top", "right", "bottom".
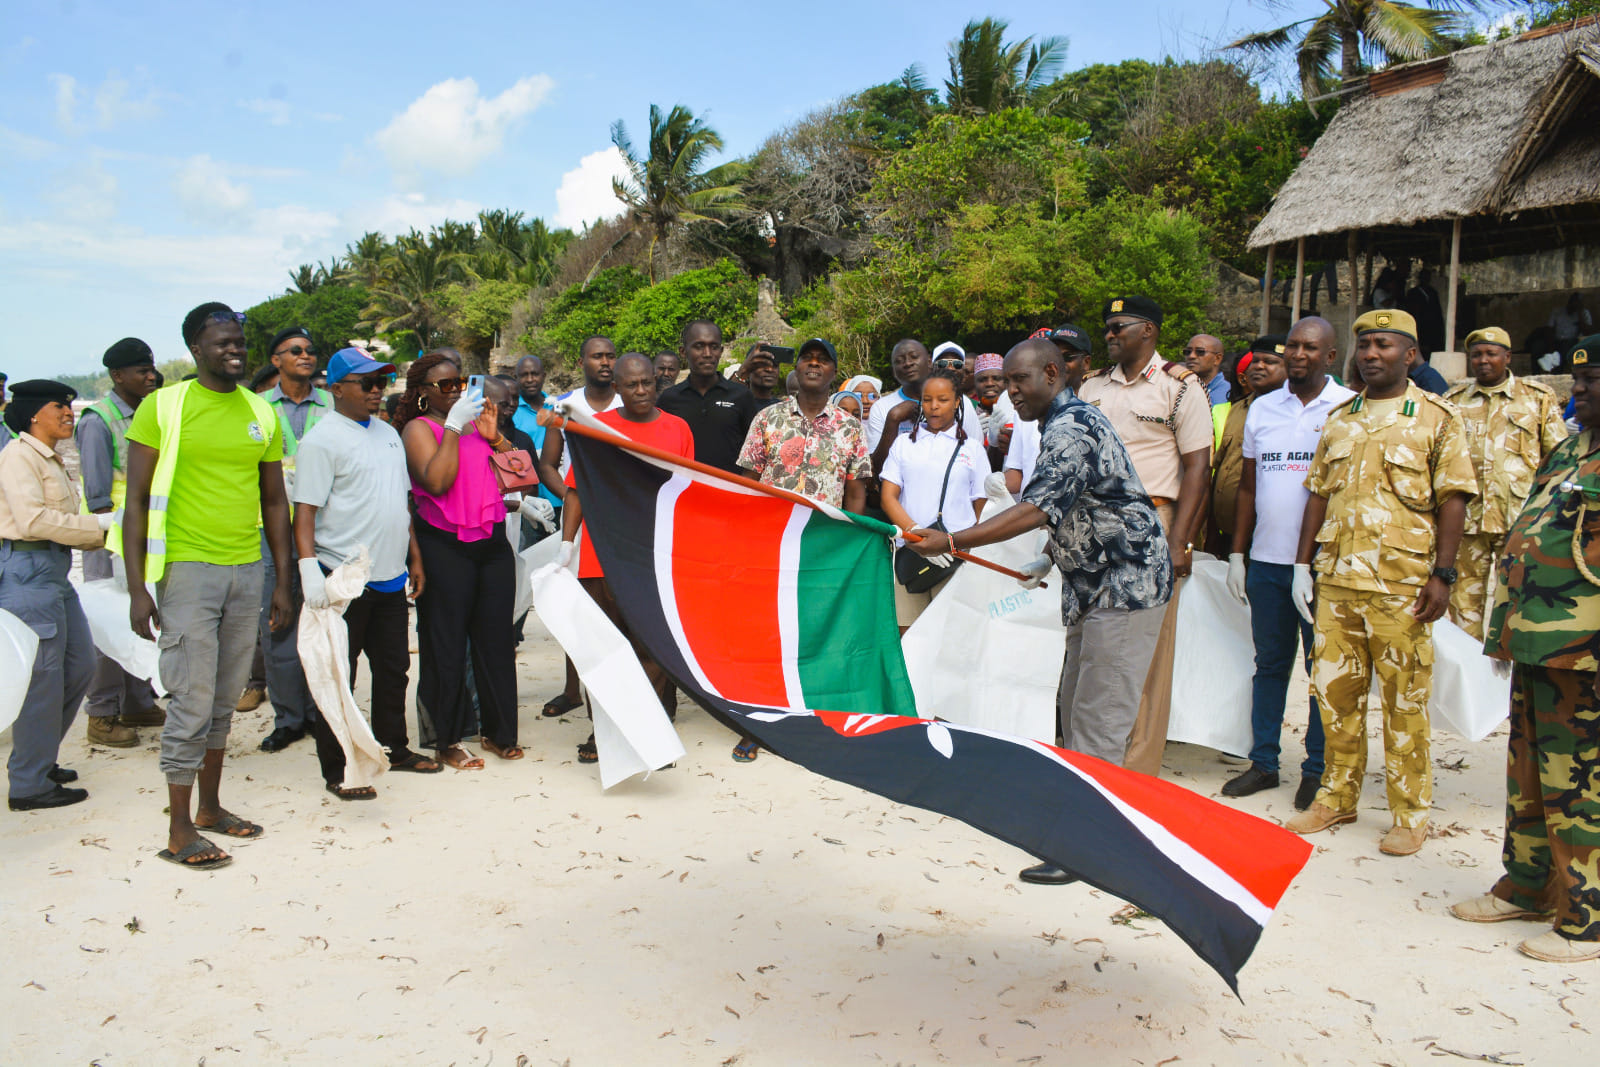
{"left": 1306, "top": 384, "right": 1478, "bottom": 829}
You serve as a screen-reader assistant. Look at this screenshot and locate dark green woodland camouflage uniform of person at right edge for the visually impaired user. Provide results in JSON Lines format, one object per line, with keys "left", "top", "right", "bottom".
{"left": 1485, "top": 429, "right": 1600, "bottom": 941}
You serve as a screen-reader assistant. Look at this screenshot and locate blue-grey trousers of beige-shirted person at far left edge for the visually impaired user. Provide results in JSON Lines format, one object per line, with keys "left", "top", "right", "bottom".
{"left": 0, "top": 544, "right": 94, "bottom": 800}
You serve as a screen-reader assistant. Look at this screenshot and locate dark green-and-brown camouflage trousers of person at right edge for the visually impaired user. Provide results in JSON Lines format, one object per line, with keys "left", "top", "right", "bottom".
{"left": 1493, "top": 664, "right": 1600, "bottom": 941}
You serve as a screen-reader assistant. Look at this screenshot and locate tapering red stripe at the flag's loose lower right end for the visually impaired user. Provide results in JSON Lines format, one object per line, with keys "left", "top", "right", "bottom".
{"left": 1056, "top": 749, "right": 1312, "bottom": 907}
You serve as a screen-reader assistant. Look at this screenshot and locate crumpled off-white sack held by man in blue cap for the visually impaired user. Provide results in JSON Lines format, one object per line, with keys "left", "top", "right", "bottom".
{"left": 296, "top": 545, "right": 389, "bottom": 789}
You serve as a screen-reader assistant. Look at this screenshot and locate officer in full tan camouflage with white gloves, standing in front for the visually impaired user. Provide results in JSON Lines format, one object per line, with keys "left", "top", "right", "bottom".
{"left": 1286, "top": 303, "right": 1478, "bottom": 856}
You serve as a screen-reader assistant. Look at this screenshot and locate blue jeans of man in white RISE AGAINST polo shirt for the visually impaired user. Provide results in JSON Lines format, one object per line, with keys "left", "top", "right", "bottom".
{"left": 1245, "top": 560, "right": 1322, "bottom": 777}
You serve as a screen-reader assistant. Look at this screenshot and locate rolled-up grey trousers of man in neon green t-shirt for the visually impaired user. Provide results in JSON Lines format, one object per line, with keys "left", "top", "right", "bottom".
{"left": 155, "top": 561, "right": 262, "bottom": 785}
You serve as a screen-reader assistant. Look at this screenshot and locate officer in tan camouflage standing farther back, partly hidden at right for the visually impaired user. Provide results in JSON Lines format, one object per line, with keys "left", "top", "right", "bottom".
{"left": 1445, "top": 326, "right": 1566, "bottom": 640}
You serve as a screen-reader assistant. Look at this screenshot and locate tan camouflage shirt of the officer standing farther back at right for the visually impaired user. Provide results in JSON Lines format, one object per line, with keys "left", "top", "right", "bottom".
{"left": 1445, "top": 374, "right": 1566, "bottom": 534}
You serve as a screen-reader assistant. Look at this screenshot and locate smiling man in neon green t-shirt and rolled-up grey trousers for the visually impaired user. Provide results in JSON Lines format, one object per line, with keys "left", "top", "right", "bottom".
{"left": 123, "top": 304, "right": 294, "bottom": 870}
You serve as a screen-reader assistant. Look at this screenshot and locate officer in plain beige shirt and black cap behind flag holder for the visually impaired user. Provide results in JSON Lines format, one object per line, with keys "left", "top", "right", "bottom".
{"left": 1078, "top": 296, "right": 1213, "bottom": 776}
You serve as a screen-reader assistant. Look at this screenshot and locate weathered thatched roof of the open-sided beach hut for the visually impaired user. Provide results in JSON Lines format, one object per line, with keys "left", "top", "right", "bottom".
{"left": 1250, "top": 22, "right": 1600, "bottom": 255}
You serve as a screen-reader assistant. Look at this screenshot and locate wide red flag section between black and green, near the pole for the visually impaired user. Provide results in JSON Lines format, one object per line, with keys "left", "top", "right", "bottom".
{"left": 672, "top": 483, "right": 795, "bottom": 707}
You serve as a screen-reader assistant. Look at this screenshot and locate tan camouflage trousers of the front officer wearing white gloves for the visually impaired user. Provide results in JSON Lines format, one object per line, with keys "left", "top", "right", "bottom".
{"left": 1310, "top": 584, "right": 1434, "bottom": 827}
